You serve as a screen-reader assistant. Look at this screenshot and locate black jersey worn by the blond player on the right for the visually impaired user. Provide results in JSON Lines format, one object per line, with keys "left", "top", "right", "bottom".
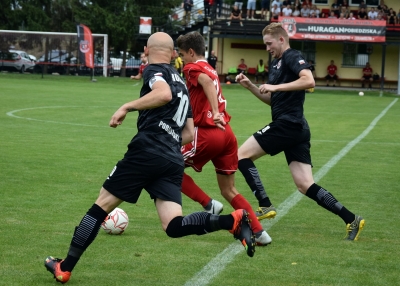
{"left": 268, "top": 49, "right": 310, "bottom": 129}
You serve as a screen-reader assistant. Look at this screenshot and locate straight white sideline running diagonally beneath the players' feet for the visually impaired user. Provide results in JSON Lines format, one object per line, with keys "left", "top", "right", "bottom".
{"left": 185, "top": 99, "right": 398, "bottom": 286}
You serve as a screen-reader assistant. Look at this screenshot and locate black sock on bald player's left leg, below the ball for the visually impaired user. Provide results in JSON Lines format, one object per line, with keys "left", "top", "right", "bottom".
{"left": 61, "top": 204, "right": 108, "bottom": 272}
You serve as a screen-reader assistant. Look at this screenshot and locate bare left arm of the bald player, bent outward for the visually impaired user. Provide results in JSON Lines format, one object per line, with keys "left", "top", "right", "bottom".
{"left": 109, "top": 81, "right": 172, "bottom": 128}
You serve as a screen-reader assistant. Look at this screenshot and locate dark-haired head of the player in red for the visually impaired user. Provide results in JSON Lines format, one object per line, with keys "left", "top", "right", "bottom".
{"left": 176, "top": 32, "right": 206, "bottom": 63}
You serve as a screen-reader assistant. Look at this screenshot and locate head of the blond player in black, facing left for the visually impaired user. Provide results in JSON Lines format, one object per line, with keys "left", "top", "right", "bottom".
{"left": 262, "top": 23, "right": 290, "bottom": 59}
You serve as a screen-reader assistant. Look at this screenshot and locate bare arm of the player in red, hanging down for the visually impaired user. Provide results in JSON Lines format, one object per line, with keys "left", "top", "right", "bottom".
{"left": 197, "top": 73, "right": 226, "bottom": 130}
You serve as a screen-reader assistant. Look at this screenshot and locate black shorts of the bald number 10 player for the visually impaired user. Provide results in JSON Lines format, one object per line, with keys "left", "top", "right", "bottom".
{"left": 103, "top": 150, "right": 184, "bottom": 205}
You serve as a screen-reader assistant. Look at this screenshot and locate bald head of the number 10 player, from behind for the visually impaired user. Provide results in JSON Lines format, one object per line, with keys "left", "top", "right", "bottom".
{"left": 144, "top": 32, "right": 174, "bottom": 63}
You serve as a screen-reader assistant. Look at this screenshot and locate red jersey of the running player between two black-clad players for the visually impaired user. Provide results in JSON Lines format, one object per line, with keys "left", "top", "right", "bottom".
{"left": 183, "top": 60, "right": 231, "bottom": 127}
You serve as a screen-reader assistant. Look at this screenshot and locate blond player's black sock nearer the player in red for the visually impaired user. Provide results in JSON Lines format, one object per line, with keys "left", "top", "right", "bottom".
{"left": 238, "top": 158, "right": 272, "bottom": 207}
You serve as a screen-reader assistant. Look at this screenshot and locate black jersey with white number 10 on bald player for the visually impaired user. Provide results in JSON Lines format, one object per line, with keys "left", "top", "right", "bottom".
{"left": 128, "top": 64, "right": 193, "bottom": 166}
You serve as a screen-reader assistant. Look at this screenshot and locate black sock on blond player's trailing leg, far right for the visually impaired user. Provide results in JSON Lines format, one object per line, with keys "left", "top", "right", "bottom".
{"left": 306, "top": 184, "right": 355, "bottom": 224}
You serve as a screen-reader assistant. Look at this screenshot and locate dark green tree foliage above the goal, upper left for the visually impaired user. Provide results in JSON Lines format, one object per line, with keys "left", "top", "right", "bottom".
{"left": 0, "top": 0, "right": 182, "bottom": 65}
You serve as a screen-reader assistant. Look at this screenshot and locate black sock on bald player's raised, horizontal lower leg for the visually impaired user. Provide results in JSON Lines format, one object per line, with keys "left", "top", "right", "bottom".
{"left": 165, "top": 212, "right": 234, "bottom": 238}
